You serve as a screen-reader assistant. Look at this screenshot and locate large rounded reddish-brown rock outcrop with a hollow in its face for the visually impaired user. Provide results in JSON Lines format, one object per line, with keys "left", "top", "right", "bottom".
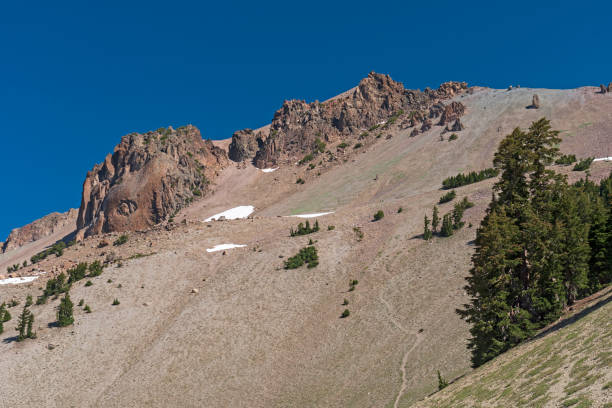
{"left": 77, "top": 125, "right": 228, "bottom": 239}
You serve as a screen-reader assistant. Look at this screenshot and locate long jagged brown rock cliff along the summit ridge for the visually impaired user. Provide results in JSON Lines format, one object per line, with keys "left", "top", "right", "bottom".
{"left": 230, "top": 72, "right": 467, "bottom": 168}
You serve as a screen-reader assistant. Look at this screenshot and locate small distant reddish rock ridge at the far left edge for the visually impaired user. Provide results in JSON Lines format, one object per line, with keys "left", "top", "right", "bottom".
{"left": 0, "top": 208, "right": 78, "bottom": 252}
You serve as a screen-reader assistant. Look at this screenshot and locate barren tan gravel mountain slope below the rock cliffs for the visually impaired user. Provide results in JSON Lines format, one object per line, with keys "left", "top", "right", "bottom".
{"left": 0, "top": 84, "right": 612, "bottom": 407}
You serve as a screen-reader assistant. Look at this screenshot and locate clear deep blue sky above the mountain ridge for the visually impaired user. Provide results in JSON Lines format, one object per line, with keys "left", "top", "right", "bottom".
{"left": 0, "top": 0, "right": 612, "bottom": 240}
